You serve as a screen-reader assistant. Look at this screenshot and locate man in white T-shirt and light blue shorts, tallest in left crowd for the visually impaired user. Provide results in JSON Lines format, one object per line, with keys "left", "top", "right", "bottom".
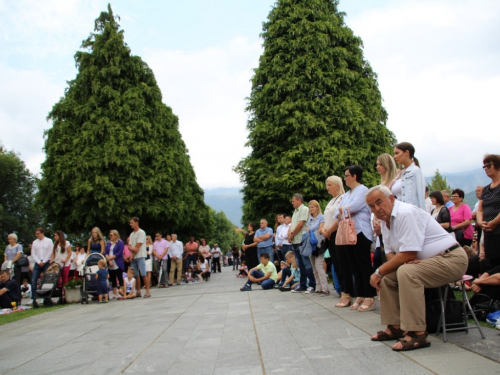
{"left": 128, "top": 217, "right": 151, "bottom": 298}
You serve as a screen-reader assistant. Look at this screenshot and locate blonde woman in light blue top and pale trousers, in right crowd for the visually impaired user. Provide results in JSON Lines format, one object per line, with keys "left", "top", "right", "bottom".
{"left": 306, "top": 199, "right": 330, "bottom": 297}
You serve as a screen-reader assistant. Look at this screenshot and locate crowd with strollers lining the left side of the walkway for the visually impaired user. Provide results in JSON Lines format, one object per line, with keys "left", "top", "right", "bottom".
{"left": 0, "top": 217, "right": 235, "bottom": 308}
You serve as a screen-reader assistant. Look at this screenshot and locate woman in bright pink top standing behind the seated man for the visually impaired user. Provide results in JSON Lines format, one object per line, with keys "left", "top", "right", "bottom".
{"left": 450, "top": 189, "right": 474, "bottom": 246}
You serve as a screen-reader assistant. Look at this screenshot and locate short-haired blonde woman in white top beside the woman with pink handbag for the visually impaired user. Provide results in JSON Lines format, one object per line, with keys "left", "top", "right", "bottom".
{"left": 322, "top": 176, "right": 345, "bottom": 295}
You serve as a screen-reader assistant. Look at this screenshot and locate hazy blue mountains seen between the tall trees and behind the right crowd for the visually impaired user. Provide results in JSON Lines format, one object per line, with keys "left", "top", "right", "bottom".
{"left": 205, "top": 168, "right": 490, "bottom": 227}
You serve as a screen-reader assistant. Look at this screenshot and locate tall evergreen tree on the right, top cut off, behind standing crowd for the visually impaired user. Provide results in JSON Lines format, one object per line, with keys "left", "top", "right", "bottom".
{"left": 235, "top": 0, "right": 395, "bottom": 222}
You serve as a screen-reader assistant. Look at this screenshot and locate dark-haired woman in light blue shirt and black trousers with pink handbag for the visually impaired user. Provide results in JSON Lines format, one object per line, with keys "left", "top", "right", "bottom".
{"left": 334, "top": 165, "right": 377, "bottom": 312}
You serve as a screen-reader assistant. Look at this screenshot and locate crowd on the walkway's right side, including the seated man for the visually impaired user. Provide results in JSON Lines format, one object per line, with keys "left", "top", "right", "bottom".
{"left": 234, "top": 142, "right": 500, "bottom": 351}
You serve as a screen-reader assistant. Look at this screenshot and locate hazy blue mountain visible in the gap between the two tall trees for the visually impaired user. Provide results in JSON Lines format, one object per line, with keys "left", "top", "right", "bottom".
{"left": 205, "top": 187, "right": 243, "bottom": 227}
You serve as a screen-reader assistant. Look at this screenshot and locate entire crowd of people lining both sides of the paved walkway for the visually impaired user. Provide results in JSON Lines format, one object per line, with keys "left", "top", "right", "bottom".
{"left": 0, "top": 142, "right": 500, "bottom": 351}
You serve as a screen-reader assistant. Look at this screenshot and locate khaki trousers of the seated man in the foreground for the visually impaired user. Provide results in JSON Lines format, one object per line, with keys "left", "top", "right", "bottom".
{"left": 380, "top": 247, "right": 468, "bottom": 331}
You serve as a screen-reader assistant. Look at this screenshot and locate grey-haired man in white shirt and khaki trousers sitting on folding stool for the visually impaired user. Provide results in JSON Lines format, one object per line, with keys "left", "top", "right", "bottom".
{"left": 365, "top": 185, "right": 467, "bottom": 351}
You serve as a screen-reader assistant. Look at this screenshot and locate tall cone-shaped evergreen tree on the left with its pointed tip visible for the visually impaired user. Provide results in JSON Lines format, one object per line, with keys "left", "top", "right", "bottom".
{"left": 39, "top": 5, "right": 211, "bottom": 235}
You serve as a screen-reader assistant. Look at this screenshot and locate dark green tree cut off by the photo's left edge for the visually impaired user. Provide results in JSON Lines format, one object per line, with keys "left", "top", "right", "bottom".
{"left": 0, "top": 146, "right": 42, "bottom": 250}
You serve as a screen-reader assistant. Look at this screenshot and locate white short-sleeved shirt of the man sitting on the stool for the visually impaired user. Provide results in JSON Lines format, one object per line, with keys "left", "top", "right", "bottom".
{"left": 381, "top": 200, "right": 457, "bottom": 259}
